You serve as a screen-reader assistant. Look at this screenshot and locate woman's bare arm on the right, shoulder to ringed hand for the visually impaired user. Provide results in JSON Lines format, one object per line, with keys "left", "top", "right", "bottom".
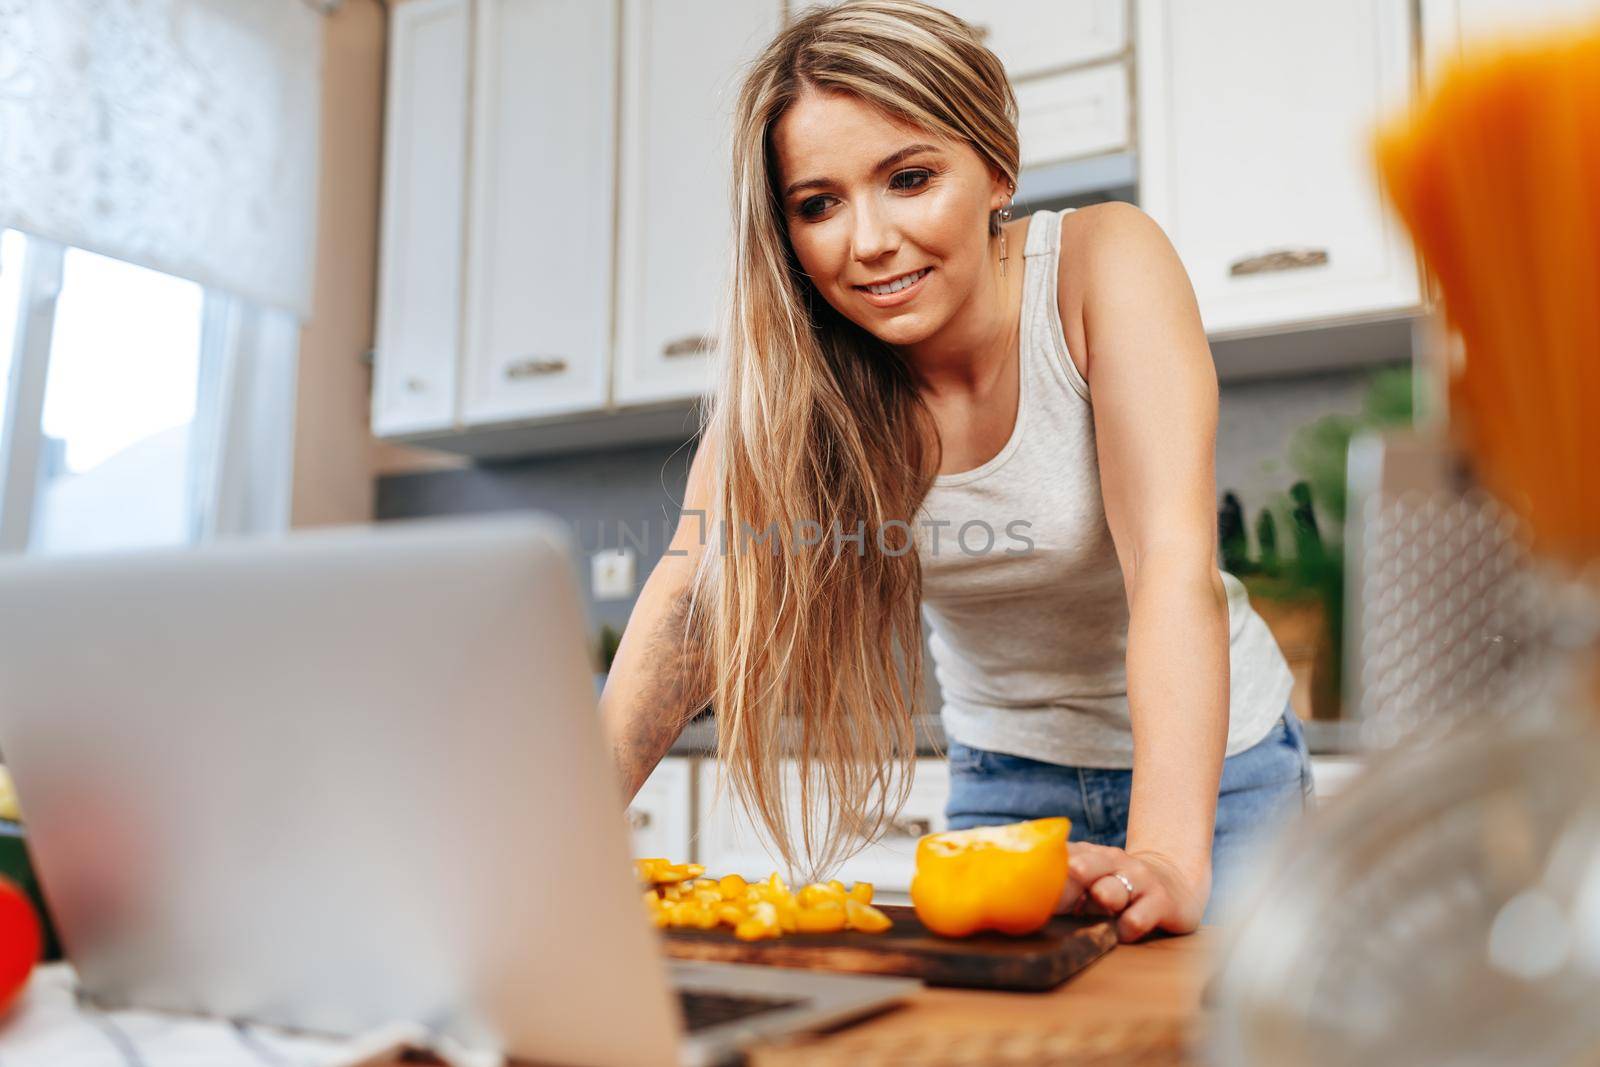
{"left": 1062, "top": 205, "right": 1229, "bottom": 941}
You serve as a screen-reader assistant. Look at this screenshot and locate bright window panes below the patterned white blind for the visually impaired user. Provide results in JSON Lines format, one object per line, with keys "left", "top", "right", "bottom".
{"left": 0, "top": 230, "right": 237, "bottom": 553}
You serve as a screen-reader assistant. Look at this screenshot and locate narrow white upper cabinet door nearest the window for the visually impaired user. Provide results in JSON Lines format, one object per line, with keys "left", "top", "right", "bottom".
{"left": 373, "top": 0, "right": 470, "bottom": 435}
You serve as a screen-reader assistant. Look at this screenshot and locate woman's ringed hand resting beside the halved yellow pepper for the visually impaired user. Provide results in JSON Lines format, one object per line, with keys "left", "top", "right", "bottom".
{"left": 1056, "top": 841, "right": 1211, "bottom": 941}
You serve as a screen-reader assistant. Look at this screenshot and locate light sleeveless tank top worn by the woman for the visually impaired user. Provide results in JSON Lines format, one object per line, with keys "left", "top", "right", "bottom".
{"left": 915, "top": 211, "right": 1293, "bottom": 768}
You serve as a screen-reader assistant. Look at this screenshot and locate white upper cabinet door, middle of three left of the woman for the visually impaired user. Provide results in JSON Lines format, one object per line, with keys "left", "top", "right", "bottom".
{"left": 462, "top": 0, "right": 618, "bottom": 426}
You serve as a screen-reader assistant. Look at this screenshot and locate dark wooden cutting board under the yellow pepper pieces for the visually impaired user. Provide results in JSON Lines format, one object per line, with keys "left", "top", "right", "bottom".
{"left": 664, "top": 904, "right": 1117, "bottom": 992}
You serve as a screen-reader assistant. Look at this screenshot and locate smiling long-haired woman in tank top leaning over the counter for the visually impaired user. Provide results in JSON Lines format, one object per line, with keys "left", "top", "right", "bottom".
{"left": 602, "top": 0, "right": 1310, "bottom": 941}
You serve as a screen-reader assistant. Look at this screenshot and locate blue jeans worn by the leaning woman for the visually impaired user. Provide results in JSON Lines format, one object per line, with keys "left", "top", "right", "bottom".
{"left": 944, "top": 710, "right": 1314, "bottom": 921}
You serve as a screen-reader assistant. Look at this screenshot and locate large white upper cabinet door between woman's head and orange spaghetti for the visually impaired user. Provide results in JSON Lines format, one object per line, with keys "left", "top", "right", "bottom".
{"left": 1134, "top": 0, "right": 1421, "bottom": 336}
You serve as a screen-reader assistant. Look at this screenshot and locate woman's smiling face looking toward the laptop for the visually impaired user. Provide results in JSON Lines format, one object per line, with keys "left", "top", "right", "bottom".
{"left": 773, "top": 90, "right": 1008, "bottom": 347}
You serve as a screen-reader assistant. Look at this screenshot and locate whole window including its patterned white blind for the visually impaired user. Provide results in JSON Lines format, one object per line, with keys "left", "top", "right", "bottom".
{"left": 0, "top": 0, "right": 316, "bottom": 553}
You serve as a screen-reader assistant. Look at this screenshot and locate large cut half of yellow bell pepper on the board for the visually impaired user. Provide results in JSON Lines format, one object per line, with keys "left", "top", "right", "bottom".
{"left": 910, "top": 817, "right": 1072, "bottom": 937}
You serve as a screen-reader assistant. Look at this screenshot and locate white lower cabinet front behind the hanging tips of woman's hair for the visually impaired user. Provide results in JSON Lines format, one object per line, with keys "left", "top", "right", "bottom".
{"left": 696, "top": 760, "right": 950, "bottom": 902}
